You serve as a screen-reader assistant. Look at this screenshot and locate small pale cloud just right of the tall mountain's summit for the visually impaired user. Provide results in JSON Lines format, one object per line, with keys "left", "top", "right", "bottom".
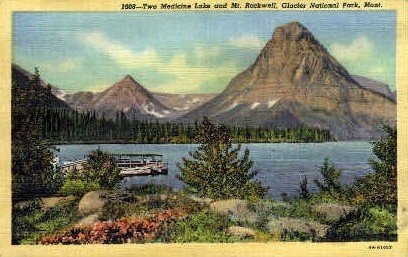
{"left": 330, "top": 37, "right": 374, "bottom": 61}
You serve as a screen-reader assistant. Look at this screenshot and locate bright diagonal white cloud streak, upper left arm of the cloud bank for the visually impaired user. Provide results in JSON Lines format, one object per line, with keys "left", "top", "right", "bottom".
{"left": 77, "top": 31, "right": 160, "bottom": 69}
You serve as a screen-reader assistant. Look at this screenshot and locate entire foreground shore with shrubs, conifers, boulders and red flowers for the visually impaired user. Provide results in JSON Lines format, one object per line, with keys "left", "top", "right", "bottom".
{"left": 12, "top": 69, "right": 397, "bottom": 244}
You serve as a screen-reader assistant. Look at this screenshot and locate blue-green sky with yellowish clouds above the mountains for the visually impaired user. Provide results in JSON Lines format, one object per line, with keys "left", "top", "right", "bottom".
{"left": 12, "top": 11, "right": 396, "bottom": 93}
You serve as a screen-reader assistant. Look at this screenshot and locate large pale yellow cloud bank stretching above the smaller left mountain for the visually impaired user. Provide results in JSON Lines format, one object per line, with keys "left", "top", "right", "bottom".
{"left": 78, "top": 31, "right": 240, "bottom": 93}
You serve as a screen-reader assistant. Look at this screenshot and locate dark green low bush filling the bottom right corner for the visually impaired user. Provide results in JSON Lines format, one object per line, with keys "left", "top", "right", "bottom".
{"left": 326, "top": 207, "right": 397, "bottom": 241}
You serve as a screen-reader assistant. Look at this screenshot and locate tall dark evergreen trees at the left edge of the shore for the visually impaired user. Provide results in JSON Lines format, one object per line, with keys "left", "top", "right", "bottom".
{"left": 11, "top": 69, "right": 63, "bottom": 201}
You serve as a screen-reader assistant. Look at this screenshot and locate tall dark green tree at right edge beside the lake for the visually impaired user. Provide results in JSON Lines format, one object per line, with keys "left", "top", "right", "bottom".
{"left": 353, "top": 127, "right": 398, "bottom": 207}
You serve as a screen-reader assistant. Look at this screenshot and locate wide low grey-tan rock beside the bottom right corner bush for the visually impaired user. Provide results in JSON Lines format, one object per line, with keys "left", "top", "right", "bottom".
{"left": 267, "top": 217, "right": 329, "bottom": 237}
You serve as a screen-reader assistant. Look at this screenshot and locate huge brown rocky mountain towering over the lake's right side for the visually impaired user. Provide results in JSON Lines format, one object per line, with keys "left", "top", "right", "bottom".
{"left": 182, "top": 22, "right": 396, "bottom": 140}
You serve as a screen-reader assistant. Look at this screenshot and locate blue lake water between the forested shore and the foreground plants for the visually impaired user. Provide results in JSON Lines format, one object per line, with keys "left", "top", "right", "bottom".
{"left": 57, "top": 142, "right": 373, "bottom": 198}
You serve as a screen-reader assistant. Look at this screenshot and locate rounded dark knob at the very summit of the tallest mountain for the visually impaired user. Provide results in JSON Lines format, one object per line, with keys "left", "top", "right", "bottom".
{"left": 272, "top": 21, "right": 314, "bottom": 41}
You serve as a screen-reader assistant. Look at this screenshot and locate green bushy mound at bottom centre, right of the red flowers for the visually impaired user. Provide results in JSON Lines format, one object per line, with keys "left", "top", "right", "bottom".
{"left": 166, "top": 211, "right": 234, "bottom": 243}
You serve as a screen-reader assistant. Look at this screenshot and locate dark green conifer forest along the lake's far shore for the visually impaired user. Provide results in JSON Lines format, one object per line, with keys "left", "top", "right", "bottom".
{"left": 36, "top": 109, "right": 334, "bottom": 144}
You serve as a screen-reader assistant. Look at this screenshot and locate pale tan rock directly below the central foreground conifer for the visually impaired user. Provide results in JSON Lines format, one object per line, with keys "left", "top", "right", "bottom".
{"left": 210, "top": 199, "right": 258, "bottom": 222}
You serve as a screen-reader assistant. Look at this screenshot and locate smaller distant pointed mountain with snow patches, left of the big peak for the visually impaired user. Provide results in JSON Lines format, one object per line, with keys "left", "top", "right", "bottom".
{"left": 59, "top": 78, "right": 216, "bottom": 120}
